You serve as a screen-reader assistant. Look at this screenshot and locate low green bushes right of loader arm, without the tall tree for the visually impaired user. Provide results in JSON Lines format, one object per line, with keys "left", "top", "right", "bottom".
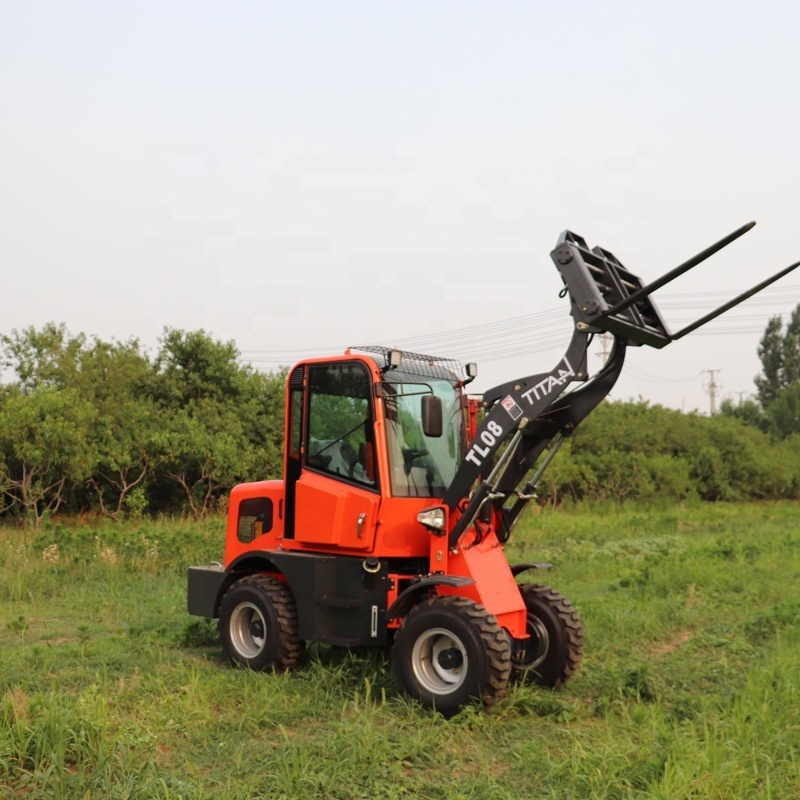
{"left": 538, "top": 401, "right": 800, "bottom": 505}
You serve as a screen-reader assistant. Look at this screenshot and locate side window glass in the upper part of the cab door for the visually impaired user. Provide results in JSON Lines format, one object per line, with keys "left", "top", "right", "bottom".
{"left": 306, "top": 364, "right": 376, "bottom": 487}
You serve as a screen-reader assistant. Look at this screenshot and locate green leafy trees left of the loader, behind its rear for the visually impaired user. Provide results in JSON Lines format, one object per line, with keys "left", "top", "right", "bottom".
{"left": 0, "top": 323, "right": 285, "bottom": 525}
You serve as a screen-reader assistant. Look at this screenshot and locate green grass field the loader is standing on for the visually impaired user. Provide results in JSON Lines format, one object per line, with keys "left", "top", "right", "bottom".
{"left": 0, "top": 503, "right": 800, "bottom": 800}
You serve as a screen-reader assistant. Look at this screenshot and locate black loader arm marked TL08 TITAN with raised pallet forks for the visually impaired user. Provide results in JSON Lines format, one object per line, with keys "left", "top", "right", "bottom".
{"left": 444, "top": 222, "right": 800, "bottom": 550}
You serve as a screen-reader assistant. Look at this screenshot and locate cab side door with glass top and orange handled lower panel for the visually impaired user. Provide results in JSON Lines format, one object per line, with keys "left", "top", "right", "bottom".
{"left": 294, "top": 361, "right": 380, "bottom": 550}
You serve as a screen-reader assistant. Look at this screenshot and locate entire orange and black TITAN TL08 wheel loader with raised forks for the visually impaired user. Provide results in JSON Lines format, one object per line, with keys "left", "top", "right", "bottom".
{"left": 188, "top": 223, "right": 800, "bottom": 715}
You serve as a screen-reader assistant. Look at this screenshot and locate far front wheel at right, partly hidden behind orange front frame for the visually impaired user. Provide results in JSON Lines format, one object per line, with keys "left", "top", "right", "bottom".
{"left": 511, "top": 583, "right": 583, "bottom": 688}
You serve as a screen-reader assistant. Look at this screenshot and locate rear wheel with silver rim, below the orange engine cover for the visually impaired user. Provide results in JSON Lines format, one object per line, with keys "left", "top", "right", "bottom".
{"left": 219, "top": 575, "right": 305, "bottom": 672}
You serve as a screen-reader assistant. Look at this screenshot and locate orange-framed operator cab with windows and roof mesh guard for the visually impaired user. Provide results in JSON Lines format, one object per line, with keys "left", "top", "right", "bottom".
{"left": 284, "top": 347, "right": 476, "bottom": 550}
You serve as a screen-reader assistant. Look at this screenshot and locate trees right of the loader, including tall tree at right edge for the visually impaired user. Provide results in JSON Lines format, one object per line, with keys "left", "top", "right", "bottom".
{"left": 540, "top": 305, "right": 800, "bottom": 504}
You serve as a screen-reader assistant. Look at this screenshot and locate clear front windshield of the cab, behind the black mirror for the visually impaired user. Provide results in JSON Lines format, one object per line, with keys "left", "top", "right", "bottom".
{"left": 382, "top": 379, "right": 464, "bottom": 497}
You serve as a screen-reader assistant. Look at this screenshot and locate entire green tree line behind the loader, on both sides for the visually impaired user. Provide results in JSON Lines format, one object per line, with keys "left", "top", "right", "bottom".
{"left": 0, "top": 306, "right": 800, "bottom": 525}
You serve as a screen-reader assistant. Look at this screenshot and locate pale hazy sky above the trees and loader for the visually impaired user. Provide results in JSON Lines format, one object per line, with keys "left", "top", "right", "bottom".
{"left": 0, "top": 0, "right": 800, "bottom": 413}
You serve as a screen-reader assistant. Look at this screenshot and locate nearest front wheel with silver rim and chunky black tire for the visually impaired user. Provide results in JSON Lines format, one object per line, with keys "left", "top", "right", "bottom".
{"left": 392, "top": 595, "right": 511, "bottom": 716}
